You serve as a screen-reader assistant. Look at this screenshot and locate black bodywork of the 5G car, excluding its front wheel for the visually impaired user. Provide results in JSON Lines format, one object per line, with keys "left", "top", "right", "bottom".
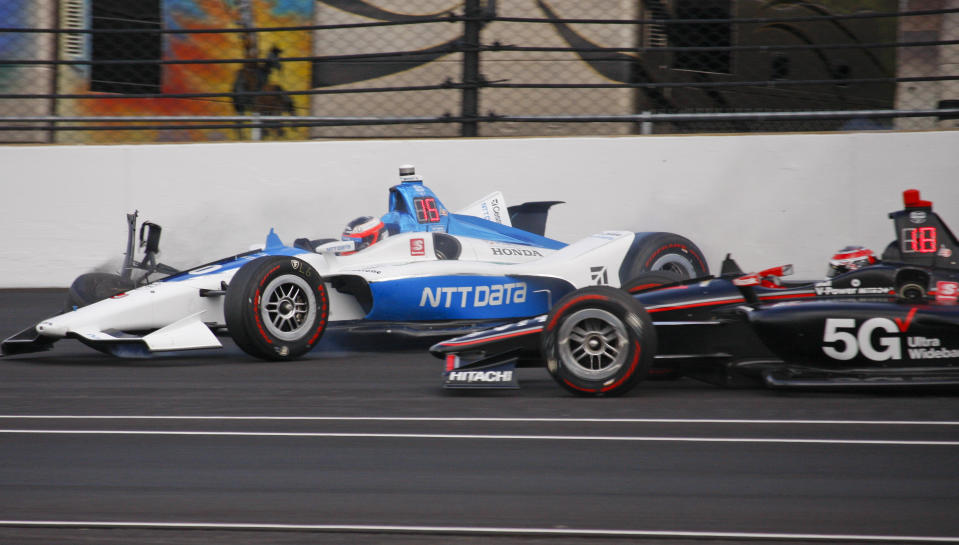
{"left": 431, "top": 192, "right": 959, "bottom": 388}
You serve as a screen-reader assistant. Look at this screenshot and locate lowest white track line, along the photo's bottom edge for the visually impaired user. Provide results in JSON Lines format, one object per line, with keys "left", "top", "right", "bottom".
{"left": 0, "top": 520, "right": 959, "bottom": 543}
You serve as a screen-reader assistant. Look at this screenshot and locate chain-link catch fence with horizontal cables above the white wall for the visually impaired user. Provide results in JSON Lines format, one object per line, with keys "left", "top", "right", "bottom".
{"left": 0, "top": 0, "right": 959, "bottom": 143}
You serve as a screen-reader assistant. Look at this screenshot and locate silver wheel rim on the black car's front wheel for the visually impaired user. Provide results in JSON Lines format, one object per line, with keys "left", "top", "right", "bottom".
{"left": 557, "top": 309, "right": 629, "bottom": 380}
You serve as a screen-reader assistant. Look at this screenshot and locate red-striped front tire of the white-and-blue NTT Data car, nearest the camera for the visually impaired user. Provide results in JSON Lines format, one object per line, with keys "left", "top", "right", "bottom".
{"left": 223, "top": 256, "right": 330, "bottom": 360}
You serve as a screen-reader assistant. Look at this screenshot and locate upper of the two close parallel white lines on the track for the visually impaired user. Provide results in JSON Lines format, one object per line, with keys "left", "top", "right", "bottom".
{"left": 0, "top": 414, "right": 959, "bottom": 426}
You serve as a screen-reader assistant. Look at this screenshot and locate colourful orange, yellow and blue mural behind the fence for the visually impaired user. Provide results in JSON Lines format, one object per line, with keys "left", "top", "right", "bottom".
{"left": 58, "top": 0, "right": 314, "bottom": 143}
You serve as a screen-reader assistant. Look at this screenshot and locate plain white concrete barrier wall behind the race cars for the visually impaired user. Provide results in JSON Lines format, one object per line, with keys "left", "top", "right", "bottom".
{"left": 0, "top": 131, "right": 959, "bottom": 288}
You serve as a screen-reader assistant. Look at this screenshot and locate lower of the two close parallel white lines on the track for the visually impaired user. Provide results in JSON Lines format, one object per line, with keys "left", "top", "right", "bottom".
{"left": 0, "top": 429, "right": 959, "bottom": 447}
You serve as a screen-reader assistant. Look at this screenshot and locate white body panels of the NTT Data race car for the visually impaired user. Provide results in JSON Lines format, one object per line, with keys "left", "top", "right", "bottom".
{"left": 36, "top": 228, "right": 635, "bottom": 352}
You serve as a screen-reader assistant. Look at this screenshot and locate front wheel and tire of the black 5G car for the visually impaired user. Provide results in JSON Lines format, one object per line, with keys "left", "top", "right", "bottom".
{"left": 541, "top": 286, "right": 656, "bottom": 396}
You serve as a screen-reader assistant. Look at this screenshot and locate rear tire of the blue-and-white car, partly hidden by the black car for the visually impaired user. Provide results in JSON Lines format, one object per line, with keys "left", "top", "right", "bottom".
{"left": 620, "top": 233, "right": 709, "bottom": 283}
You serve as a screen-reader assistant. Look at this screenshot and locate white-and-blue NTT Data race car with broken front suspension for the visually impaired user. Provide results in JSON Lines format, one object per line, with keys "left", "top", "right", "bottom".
{"left": 2, "top": 166, "right": 708, "bottom": 360}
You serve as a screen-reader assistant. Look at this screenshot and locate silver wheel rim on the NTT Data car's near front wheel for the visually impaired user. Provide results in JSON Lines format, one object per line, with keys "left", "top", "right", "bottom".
{"left": 260, "top": 274, "right": 316, "bottom": 341}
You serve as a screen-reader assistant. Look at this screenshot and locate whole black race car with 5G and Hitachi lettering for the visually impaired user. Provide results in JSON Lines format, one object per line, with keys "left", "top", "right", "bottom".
{"left": 430, "top": 190, "right": 959, "bottom": 396}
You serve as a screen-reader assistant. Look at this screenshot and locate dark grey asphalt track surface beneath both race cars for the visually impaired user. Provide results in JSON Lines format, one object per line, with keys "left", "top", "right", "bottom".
{"left": 0, "top": 290, "right": 959, "bottom": 545}
